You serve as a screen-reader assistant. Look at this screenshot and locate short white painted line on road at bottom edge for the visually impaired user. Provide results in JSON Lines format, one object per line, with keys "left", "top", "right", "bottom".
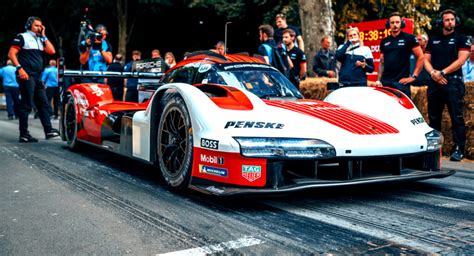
{"left": 156, "top": 236, "right": 265, "bottom": 256}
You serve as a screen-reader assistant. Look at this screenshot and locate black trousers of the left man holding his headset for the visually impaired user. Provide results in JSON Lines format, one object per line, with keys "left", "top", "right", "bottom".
{"left": 17, "top": 76, "right": 52, "bottom": 136}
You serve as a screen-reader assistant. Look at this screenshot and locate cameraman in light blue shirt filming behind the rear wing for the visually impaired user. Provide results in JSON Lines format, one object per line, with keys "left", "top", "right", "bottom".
{"left": 79, "top": 24, "right": 113, "bottom": 75}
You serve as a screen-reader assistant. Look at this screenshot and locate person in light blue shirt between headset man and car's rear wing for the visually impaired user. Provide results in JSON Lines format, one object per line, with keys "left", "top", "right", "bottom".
{"left": 41, "top": 60, "right": 59, "bottom": 119}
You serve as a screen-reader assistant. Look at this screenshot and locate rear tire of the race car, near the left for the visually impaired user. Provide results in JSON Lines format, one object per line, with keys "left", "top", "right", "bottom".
{"left": 62, "top": 95, "right": 80, "bottom": 150}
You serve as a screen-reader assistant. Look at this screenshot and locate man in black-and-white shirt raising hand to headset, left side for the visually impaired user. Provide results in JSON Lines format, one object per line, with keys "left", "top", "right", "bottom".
{"left": 8, "top": 17, "right": 59, "bottom": 142}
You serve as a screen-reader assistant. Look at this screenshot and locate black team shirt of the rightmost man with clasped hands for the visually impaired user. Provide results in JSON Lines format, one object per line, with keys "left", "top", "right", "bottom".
{"left": 426, "top": 32, "right": 471, "bottom": 77}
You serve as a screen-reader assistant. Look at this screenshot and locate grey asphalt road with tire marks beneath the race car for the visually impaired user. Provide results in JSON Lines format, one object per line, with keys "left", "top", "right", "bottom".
{"left": 0, "top": 111, "right": 474, "bottom": 255}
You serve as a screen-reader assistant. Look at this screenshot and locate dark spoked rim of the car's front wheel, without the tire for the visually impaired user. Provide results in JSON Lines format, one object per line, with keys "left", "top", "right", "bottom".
{"left": 160, "top": 107, "right": 188, "bottom": 177}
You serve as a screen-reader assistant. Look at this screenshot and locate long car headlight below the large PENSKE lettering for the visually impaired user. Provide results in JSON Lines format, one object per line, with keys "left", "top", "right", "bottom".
{"left": 234, "top": 137, "right": 336, "bottom": 158}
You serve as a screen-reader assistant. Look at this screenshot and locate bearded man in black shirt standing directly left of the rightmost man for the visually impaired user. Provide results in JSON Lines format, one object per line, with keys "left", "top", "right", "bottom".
{"left": 377, "top": 12, "right": 423, "bottom": 97}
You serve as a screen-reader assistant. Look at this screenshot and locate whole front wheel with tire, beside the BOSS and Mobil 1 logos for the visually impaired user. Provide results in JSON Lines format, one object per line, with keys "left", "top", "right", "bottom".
{"left": 156, "top": 94, "right": 193, "bottom": 190}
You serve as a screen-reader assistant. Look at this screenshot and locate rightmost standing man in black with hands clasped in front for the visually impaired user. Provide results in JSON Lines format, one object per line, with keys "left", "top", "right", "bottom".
{"left": 425, "top": 9, "right": 471, "bottom": 161}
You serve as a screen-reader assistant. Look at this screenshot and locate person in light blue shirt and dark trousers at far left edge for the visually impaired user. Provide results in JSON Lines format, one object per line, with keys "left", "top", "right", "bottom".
{"left": 0, "top": 60, "right": 20, "bottom": 120}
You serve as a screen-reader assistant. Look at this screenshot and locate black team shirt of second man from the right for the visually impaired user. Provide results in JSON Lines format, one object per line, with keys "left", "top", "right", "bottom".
{"left": 380, "top": 31, "right": 420, "bottom": 83}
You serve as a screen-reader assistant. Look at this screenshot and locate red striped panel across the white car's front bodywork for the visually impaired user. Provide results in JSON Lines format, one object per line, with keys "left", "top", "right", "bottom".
{"left": 265, "top": 100, "right": 398, "bottom": 135}
